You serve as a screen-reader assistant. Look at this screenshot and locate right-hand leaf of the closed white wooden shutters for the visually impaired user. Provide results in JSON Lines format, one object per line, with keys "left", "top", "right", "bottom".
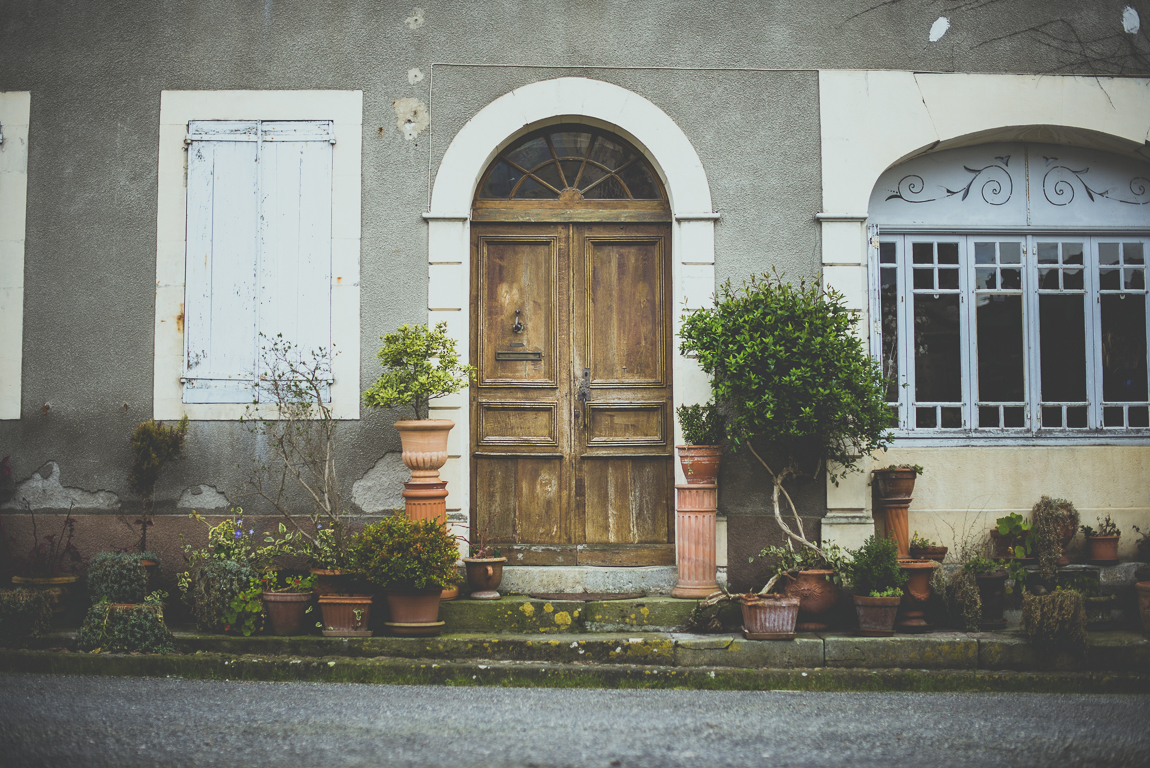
{"left": 259, "top": 122, "right": 335, "bottom": 395}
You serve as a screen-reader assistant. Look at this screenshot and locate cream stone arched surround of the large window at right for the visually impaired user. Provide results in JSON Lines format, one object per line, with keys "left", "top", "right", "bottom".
{"left": 817, "top": 70, "right": 1150, "bottom": 546}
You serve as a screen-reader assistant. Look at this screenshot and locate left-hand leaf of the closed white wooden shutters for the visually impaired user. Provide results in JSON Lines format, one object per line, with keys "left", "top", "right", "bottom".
{"left": 184, "top": 121, "right": 259, "bottom": 402}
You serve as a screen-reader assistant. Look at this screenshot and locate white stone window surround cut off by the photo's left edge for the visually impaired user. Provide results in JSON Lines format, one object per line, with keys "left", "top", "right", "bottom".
{"left": 0, "top": 91, "right": 32, "bottom": 418}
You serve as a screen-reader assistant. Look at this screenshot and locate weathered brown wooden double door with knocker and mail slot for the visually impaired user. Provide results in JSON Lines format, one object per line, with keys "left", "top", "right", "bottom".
{"left": 470, "top": 223, "right": 675, "bottom": 566}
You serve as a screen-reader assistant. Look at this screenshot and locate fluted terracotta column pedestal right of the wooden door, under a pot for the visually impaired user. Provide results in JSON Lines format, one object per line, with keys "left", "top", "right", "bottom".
{"left": 670, "top": 483, "right": 719, "bottom": 599}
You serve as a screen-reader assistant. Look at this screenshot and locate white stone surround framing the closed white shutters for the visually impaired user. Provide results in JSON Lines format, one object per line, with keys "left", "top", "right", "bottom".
{"left": 153, "top": 91, "right": 363, "bottom": 420}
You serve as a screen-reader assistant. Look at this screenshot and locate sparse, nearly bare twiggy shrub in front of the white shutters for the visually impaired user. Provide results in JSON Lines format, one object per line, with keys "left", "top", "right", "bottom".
{"left": 240, "top": 333, "right": 348, "bottom": 568}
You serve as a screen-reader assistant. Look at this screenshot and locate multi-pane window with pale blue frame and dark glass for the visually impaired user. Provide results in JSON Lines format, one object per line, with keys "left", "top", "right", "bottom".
{"left": 872, "top": 232, "right": 1150, "bottom": 437}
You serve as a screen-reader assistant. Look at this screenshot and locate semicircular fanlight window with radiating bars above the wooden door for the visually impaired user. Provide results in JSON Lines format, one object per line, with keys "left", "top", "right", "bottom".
{"left": 476, "top": 124, "right": 666, "bottom": 206}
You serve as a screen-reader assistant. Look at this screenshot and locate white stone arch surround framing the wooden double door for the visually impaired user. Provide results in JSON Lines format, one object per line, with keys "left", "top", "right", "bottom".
{"left": 423, "top": 77, "right": 719, "bottom": 558}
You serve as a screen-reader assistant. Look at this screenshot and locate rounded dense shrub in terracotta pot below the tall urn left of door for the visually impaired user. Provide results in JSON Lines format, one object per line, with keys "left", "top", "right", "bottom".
{"left": 353, "top": 515, "right": 459, "bottom": 635}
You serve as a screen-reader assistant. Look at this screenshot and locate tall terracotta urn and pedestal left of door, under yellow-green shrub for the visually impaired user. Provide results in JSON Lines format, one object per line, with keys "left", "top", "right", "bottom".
{"left": 396, "top": 418, "right": 459, "bottom": 600}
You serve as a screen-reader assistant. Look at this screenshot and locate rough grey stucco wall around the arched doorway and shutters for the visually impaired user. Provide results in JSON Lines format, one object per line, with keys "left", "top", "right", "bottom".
{"left": 0, "top": 0, "right": 1150, "bottom": 531}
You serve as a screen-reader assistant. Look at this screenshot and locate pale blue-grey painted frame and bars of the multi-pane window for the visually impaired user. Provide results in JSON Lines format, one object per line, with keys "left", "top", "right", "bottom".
{"left": 868, "top": 231, "right": 1150, "bottom": 445}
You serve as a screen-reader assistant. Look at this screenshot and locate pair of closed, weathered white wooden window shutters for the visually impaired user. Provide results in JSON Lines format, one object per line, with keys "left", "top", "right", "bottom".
{"left": 184, "top": 121, "right": 334, "bottom": 402}
